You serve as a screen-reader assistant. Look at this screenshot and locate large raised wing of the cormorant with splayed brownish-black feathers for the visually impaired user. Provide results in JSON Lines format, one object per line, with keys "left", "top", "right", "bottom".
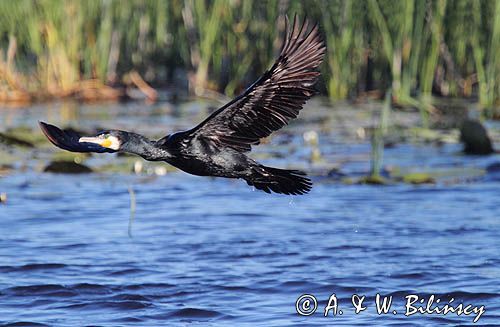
{"left": 189, "top": 16, "right": 325, "bottom": 152}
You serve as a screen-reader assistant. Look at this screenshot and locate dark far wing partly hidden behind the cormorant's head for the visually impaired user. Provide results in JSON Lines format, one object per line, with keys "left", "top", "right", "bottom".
{"left": 39, "top": 122, "right": 116, "bottom": 153}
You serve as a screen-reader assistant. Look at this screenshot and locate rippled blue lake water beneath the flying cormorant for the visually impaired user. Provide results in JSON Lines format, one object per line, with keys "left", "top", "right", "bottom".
{"left": 0, "top": 102, "right": 500, "bottom": 326}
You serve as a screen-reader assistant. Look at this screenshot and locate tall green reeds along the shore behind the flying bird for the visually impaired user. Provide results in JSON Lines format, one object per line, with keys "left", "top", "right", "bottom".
{"left": 0, "top": 0, "right": 500, "bottom": 118}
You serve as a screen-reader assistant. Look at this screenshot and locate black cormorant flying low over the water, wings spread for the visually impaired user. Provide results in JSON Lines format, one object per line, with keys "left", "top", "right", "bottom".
{"left": 40, "top": 17, "right": 325, "bottom": 195}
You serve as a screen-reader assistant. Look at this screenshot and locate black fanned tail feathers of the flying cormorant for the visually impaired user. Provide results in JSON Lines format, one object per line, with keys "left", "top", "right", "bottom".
{"left": 245, "top": 165, "right": 312, "bottom": 195}
